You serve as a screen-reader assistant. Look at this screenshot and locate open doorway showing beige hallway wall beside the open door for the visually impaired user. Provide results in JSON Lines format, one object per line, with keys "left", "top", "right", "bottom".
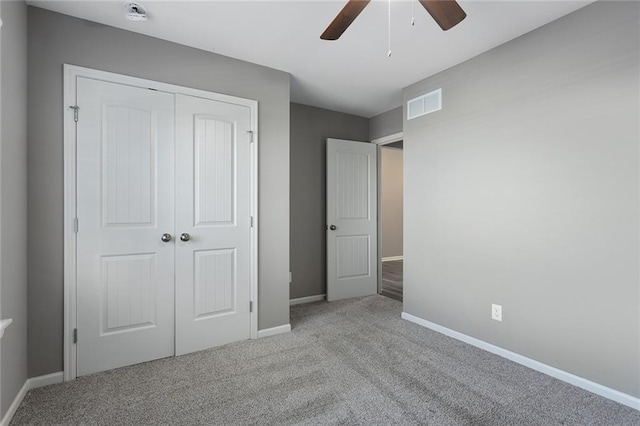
{"left": 374, "top": 134, "right": 404, "bottom": 302}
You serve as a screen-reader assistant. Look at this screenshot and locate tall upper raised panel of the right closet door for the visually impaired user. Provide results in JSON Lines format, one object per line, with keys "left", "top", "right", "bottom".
{"left": 194, "top": 115, "right": 236, "bottom": 226}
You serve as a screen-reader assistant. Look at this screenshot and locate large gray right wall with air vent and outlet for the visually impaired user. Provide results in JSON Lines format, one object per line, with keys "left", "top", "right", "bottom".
{"left": 404, "top": 2, "right": 640, "bottom": 397}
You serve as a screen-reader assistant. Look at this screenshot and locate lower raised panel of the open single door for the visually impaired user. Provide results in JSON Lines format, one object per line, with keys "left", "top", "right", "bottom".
{"left": 336, "top": 235, "right": 371, "bottom": 279}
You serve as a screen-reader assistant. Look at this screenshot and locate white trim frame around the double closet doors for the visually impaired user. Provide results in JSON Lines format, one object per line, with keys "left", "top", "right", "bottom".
{"left": 62, "top": 64, "right": 260, "bottom": 382}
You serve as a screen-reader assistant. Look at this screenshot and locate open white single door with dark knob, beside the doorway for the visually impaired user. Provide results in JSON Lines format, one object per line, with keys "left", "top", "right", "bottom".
{"left": 327, "top": 139, "right": 378, "bottom": 301}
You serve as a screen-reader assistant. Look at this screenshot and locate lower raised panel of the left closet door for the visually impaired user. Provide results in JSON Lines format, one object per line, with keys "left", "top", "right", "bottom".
{"left": 101, "top": 253, "right": 157, "bottom": 335}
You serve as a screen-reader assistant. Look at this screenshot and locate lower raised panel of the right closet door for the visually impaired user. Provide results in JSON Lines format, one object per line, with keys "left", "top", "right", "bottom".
{"left": 194, "top": 249, "right": 236, "bottom": 319}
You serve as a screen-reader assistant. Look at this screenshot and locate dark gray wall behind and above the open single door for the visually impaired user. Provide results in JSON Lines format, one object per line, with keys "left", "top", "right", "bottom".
{"left": 290, "top": 104, "right": 369, "bottom": 299}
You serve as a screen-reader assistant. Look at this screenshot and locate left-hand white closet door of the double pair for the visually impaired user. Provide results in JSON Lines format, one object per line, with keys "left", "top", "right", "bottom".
{"left": 76, "top": 78, "right": 174, "bottom": 376}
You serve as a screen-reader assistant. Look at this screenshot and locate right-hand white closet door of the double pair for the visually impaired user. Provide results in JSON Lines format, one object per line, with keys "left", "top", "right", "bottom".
{"left": 176, "top": 95, "right": 252, "bottom": 355}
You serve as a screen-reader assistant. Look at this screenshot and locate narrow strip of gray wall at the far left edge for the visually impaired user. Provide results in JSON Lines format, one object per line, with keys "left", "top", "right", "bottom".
{"left": 0, "top": 1, "right": 27, "bottom": 418}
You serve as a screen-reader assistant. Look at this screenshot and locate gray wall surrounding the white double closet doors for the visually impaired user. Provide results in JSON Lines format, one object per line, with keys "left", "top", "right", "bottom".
{"left": 28, "top": 7, "right": 289, "bottom": 376}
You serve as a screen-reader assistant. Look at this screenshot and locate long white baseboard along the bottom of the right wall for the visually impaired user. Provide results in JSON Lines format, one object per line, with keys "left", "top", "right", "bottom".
{"left": 402, "top": 312, "right": 640, "bottom": 410}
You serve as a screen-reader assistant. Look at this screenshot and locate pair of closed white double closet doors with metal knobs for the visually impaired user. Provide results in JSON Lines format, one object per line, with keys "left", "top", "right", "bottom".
{"left": 76, "top": 77, "right": 251, "bottom": 376}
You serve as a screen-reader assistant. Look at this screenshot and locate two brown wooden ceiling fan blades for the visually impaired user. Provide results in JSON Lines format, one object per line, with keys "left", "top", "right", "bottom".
{"left": 320, "top": 0, "right": 467, "bottom": 40}
